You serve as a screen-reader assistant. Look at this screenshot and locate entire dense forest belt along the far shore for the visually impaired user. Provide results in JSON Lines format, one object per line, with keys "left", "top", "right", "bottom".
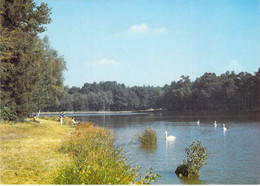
{"left": 47, "top": 68, "right": 260, "bottom": 112}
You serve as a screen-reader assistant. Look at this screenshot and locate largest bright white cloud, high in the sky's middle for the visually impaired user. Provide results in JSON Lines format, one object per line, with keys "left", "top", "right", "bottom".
{"left": 126, "top": 23, "right": 167, "bottom": 33}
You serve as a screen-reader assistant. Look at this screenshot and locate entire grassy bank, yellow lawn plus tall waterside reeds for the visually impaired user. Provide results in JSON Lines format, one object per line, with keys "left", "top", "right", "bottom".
{"left": 0, "top": 117, "right": 158, "bottom": 184}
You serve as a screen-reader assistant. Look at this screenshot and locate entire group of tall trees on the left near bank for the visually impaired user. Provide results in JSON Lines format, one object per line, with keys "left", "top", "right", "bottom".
{"left": 0, "top": 0, "right": 66, "bottom": 120}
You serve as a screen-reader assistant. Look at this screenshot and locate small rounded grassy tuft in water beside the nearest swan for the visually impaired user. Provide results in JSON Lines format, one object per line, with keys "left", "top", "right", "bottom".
{"left": 137, "top": 129, "right": 157, "bottom": 145}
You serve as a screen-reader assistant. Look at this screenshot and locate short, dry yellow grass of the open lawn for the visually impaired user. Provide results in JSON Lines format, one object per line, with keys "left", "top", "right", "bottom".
{"left": 0, "top": 119, "right": 75, "bottom": 184}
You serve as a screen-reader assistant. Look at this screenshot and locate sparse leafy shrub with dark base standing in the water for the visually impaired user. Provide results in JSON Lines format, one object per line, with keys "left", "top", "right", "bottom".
{"left": 175, "top": 141, "right": 208, "bottom": 177}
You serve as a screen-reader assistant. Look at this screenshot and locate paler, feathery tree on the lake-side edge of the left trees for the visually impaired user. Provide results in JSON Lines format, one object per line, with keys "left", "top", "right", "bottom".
{"left": 33, "top": 36, "right": 66, "bottom": 109}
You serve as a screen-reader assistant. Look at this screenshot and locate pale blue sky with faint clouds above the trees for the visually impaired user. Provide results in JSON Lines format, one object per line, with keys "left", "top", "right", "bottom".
{"left": 36, "top": 0, "right": 260, "bottom": 87}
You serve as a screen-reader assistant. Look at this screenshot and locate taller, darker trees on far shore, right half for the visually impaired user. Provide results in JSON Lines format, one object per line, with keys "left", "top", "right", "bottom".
{"left": 162, "top": 68, "right": 260, "bottom": 112}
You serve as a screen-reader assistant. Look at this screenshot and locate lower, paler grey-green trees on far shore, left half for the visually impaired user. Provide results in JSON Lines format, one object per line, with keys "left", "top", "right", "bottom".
{"left": 50, "top": 81, "right": 161, "bottom": 111}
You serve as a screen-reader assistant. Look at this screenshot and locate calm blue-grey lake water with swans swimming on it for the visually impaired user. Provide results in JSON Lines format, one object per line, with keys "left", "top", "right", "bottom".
{"left": 63, "top": 113, "right": 260, "bottom": 184}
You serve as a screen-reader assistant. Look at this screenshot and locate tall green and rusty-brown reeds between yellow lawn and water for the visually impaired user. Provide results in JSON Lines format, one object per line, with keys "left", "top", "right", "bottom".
{"left": 54, "top": 124, "right": 158, "bottom": 185}
